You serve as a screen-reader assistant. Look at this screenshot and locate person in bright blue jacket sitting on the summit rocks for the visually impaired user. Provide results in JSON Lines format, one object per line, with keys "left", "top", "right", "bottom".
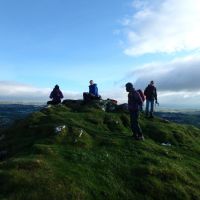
{"left": 83, "top": 80, "right": 101, "bottom": 102}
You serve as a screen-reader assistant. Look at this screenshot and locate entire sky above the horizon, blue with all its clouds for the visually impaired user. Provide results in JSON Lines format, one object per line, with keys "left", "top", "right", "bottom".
{"left": 0, "top": 0, "right": 200, "bottom": 108}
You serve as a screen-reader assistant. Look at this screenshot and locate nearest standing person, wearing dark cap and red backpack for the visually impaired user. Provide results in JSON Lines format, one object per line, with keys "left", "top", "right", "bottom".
{"left": 126, "top": 83, "right": 144, "bottom": 140}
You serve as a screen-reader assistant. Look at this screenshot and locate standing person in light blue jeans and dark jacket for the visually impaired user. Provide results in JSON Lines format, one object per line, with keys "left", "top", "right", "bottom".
{"left": 144, "top": 81, "right": 158, "bottom": 118}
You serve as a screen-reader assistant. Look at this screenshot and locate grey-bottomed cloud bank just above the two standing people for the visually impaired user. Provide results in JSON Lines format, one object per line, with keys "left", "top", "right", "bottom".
{"left": 126, "top": 55, "right": 200, "bottom": 92}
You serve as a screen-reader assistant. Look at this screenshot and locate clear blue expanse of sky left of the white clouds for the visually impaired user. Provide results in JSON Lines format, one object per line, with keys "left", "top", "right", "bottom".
{"left": 0, "top": 0, "right": 132, "bottom": 90}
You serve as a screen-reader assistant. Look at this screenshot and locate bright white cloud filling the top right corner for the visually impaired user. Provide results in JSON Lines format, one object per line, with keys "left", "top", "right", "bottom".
{"left": 122, "top": 0, "right": 200, "bottom": 56}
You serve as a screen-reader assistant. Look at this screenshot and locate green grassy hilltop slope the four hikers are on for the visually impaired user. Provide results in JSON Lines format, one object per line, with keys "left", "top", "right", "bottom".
{"left": 0, "top": 101, "right": 200, "bottom": 200}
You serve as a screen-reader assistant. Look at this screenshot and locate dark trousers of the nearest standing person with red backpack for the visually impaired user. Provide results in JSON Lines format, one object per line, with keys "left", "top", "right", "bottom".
{"left": 130, "top": 111, "right": 142, "bottom": 137}
